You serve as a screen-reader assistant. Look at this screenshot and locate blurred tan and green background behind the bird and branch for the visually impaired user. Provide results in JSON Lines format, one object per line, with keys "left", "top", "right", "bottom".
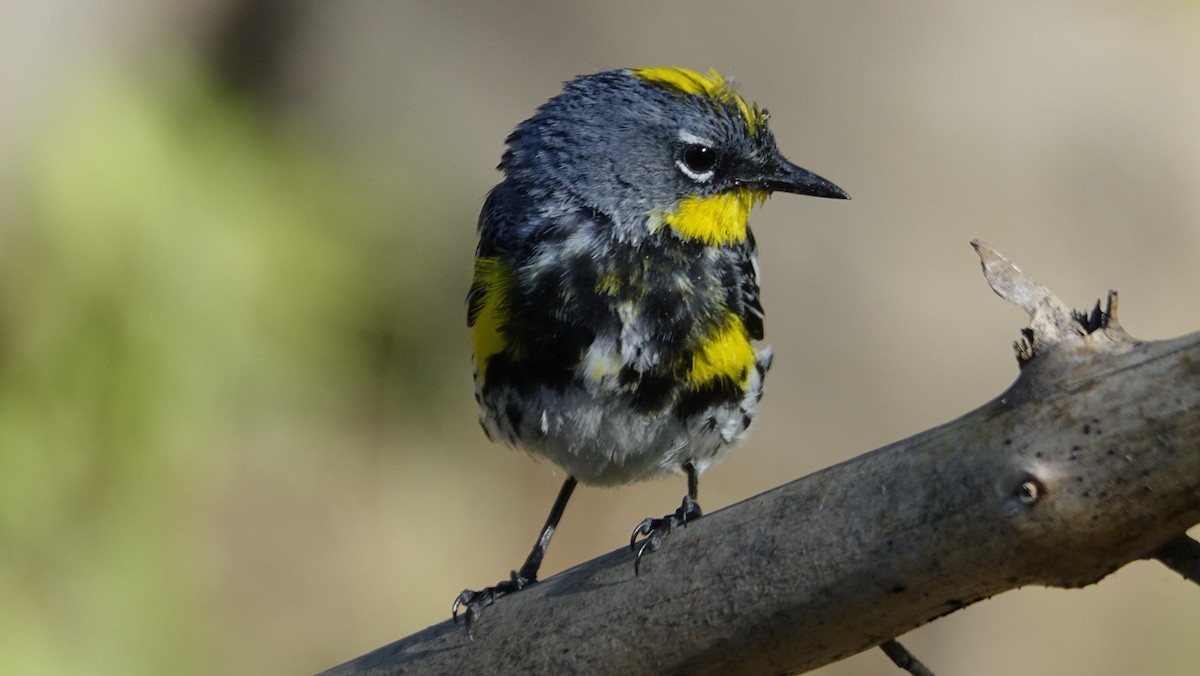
{"left": 0, "top": 0, "right": 1200, "bottom": 675}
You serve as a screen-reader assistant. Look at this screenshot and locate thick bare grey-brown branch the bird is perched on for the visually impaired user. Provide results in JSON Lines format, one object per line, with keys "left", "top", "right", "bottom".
{"left": 326, "top": 241, "right": 1200, "bottom": 676}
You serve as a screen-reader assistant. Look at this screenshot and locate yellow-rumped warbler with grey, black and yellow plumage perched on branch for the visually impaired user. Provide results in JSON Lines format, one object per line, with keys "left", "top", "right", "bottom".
{"left": 454, "top": 67, "right": 847, "bottom": 627}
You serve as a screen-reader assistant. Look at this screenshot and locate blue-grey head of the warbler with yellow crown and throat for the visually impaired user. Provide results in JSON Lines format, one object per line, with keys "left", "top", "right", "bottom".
{"left": 500, "top": 66, "right": 847, "bottom": 244}
